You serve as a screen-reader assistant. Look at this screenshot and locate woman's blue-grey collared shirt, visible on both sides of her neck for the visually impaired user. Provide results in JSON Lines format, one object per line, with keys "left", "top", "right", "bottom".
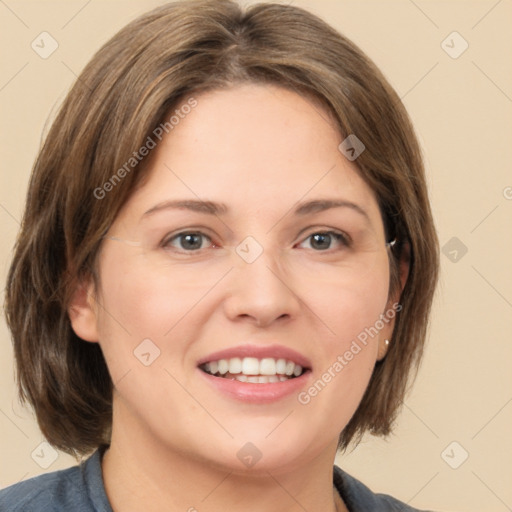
{"left": 0, "top": 451, "right": 434, "bottom": 512}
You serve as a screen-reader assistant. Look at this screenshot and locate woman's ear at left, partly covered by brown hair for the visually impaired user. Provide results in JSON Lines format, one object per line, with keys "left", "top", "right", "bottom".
{"left": 67, "top": 276, "right": 99, "bottom": 342}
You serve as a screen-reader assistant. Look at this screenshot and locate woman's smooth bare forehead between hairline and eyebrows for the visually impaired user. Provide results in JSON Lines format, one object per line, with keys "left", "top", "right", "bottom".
{"left": 123, "top": 84, "right": 378, "bottom": 224}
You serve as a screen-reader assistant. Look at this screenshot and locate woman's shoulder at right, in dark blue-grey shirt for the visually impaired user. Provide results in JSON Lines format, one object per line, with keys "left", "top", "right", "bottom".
{"left": 334, "top": 466, "right": 436, "bottom": 512}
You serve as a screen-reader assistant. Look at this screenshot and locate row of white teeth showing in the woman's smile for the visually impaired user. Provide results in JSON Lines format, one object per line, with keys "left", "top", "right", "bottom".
{"left": 202, "top": 357, "right": 303, "bottom": 384}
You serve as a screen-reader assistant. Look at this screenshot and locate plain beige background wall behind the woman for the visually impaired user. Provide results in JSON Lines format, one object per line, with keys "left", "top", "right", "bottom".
{"left": 0, "top": 0, "right": 512, "bottom": 512}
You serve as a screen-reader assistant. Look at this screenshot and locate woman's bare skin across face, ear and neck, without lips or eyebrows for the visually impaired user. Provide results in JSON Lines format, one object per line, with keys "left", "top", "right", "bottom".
{"left": 69, "top": 84, "right": 408, "bottom": 512}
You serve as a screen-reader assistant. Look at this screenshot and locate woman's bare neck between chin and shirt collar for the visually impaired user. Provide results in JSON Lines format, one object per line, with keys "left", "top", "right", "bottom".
{"left": 102, "top": 400, "right": 347, "bottom": 512}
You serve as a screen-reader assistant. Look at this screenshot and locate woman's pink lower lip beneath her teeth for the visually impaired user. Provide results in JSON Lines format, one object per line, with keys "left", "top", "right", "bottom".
{"left": 198, "top": 368, "right": 311, "bottom": 404}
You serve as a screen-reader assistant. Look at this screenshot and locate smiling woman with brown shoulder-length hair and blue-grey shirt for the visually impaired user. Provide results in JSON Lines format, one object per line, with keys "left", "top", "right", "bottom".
{"left": 0, "top": 0, "right": 438, "bottom": 512}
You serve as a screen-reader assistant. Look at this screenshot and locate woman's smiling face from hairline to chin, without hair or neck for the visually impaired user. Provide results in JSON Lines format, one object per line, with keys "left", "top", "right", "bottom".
{"left": 73, "top": 85, "right": 393, "bottom": 471}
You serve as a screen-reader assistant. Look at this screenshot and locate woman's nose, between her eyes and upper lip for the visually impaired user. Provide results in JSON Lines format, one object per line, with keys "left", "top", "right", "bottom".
{"left": 224, "top": 247, "right": 301, "bottom": 327}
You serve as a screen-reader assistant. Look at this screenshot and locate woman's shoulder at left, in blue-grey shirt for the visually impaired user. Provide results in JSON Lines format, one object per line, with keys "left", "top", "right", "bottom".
{"left": 0, "top": 452, "right": 111, "bottom": 512}
